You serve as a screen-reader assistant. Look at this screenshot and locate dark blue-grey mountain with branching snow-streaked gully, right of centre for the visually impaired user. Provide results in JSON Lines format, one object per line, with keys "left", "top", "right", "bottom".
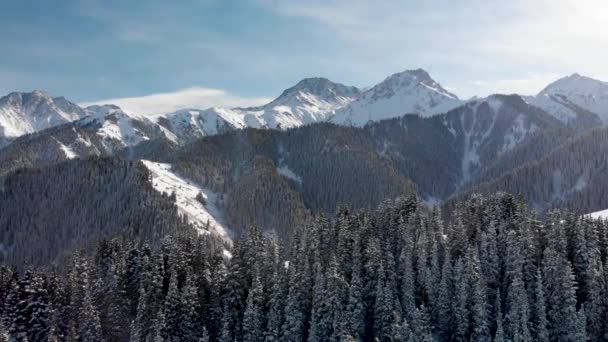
{"left": 365, "top": 95, "right": 563, "bottom": 202}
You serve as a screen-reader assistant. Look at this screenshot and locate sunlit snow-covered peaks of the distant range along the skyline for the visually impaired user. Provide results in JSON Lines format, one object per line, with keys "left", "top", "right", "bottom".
{"left": 0, "top": 69, "right": 608, "bottom": 150}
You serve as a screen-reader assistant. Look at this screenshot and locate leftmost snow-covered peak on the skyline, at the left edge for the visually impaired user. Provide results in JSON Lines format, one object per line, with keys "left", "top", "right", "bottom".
{"left": 0, "top": 90, "right": 87, "bottom": 147}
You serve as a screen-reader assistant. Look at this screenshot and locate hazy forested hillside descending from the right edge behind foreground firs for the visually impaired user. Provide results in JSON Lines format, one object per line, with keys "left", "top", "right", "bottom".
{"left": 457, "top": 128, "right": 608, "bottom": 212}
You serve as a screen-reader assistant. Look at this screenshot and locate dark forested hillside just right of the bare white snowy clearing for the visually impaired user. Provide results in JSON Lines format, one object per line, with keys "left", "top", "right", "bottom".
{"left": 175, "top": 124, "right": 415, "bottom": 236}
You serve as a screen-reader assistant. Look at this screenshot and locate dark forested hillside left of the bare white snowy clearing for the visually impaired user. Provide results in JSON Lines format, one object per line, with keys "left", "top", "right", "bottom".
{"left": 0, "top": 157, "right": 205, "bottom": 268}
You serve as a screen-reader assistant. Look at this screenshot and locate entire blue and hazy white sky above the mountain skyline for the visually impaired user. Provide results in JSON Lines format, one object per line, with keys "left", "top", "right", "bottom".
{"left": 0, "top": 0, "right": 608, "bottom": 110}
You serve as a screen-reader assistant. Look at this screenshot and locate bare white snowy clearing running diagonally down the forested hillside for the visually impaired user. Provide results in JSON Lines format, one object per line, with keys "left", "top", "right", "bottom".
{"left": 142, "top": 160, "right": 230, "bottom": 241}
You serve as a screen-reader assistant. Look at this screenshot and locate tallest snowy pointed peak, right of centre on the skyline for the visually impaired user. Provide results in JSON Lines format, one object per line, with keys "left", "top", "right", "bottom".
{"left": 331, "top": 69, "right": 463, "bottom": 126}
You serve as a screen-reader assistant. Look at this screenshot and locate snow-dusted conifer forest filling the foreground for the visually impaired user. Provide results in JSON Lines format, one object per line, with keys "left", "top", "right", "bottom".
{"left": 0, "top": 193, "right": 608, "bottom": 342}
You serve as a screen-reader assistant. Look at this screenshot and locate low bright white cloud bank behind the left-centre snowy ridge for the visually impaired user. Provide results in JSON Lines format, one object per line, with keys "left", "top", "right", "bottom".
{"left": 79, "top": 87, "right": 272, "bottom": 116}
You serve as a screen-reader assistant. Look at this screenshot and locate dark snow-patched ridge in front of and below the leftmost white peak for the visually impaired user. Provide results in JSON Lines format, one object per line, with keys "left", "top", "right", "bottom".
{"left": 0, "top": 105, "right": 177, "bottom": 178}
